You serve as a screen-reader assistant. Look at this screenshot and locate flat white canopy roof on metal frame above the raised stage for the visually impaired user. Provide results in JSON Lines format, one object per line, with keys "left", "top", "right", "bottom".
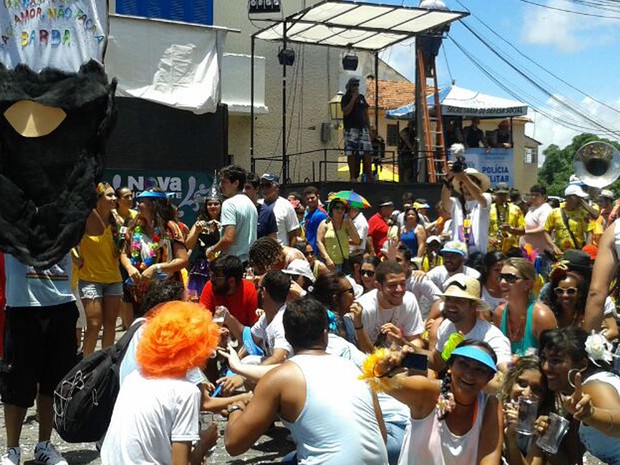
{"left": 255, "top": 0, "right": 468, "bottom": 51}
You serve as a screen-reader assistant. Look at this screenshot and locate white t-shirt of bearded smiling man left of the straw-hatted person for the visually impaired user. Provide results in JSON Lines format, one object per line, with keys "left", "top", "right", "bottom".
{"left": 357, "top": 289, "right": 424, "bottom": 344}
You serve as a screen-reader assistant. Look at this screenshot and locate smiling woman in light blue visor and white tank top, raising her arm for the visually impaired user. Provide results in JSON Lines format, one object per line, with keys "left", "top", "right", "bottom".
{"left": 364, "top": 340, "right": 503, "bottom": 465}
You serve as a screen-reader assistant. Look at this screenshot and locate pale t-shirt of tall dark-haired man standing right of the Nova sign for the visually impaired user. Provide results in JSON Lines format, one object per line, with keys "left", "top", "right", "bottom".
{"left": 220, "top": 192, "right": 258, "bottom": 262}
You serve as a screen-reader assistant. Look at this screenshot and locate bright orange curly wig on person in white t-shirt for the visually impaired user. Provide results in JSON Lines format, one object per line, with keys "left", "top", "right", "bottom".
{"left": 136, "top": 301, "right": 220, "bottom": 378}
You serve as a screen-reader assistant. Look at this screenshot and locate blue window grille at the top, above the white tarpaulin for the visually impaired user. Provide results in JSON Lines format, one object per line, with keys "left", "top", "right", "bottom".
{"left": 116, "top": 0, "right": 213, "bottom": 26}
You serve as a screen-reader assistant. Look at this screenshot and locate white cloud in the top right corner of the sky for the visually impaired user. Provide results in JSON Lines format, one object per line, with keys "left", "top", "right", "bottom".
{"left": 523, "top": 0, "right": 613, "bottom": 53}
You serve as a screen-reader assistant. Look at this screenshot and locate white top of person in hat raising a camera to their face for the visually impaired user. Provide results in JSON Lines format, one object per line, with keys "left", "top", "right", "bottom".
{"left": 449, "top": 192, "right": 493, "bottom": 253}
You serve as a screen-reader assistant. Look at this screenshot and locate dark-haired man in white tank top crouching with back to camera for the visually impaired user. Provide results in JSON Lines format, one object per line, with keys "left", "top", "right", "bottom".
{"left": 225, "top": 297, "right": 388, "bottom": 465}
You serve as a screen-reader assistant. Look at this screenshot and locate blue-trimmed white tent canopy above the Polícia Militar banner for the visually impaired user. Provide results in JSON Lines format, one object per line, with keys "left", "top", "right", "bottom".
{"left": 386, "top": 85, "right": 527, "bottom": 120}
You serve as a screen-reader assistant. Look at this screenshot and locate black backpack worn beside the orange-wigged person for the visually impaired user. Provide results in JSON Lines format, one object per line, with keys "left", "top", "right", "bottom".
{"left": 54, "top": 322, "right": 142, "bottom": 443}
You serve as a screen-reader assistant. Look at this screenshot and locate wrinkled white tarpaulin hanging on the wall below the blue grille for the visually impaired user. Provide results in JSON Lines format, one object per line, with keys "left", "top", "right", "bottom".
{"left": 105, "top": 15, "right": 226, "bottom": 114}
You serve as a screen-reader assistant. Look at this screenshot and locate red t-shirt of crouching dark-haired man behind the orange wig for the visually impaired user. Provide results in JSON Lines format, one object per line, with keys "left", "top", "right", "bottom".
{"left": 200, "top": 279, "right": 258, "bottom": 326}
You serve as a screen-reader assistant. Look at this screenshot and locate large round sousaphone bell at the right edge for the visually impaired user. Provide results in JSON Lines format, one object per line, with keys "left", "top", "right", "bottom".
{"left": 573, "top": 141, "right": 620, "bottom": 189}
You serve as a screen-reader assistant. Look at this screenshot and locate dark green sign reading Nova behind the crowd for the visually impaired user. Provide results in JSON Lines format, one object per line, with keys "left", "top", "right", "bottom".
{"left": 103, "top": 168, "right": 213, "bottom": 227}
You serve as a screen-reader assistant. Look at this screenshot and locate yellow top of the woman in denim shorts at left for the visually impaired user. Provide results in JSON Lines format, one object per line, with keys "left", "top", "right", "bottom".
{"left": 78, "top": 225, "right": 122, "bottom": 284}
